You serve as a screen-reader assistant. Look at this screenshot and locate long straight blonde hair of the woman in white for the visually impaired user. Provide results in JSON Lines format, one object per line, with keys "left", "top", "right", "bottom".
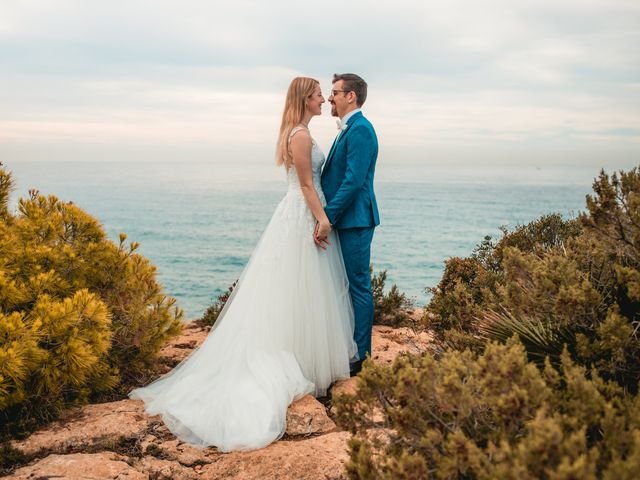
{"left": 276, "top": 77, "right": 320, "bottom": 168}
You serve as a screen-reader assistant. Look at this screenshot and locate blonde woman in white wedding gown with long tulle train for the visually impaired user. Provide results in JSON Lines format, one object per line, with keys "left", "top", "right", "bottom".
{"left": 129, "top": 77, "right": 357, "bottom": 452}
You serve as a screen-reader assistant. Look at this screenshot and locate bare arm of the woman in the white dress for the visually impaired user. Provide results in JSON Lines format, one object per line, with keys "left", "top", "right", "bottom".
{"left": 290, "top": 130, "right": 331, "bottom": 238}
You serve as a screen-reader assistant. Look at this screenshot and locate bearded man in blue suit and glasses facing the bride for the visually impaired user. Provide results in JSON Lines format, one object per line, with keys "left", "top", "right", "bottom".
{"left": 314, "top": 73, "right": 380, "bottom": 376}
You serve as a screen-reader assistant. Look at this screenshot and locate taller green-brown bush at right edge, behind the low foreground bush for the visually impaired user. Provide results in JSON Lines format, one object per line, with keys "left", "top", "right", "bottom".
{"left": 424, "top": 168, "right": 640, "bottom": 391}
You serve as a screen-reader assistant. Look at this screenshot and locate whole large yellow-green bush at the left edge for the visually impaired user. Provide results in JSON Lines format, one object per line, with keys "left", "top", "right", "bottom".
{"left": 0, "top": 168, "right": 182, "bottom": 434}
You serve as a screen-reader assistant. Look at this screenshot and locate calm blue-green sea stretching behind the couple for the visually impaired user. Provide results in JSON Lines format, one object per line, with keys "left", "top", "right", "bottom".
{"left": 7, "top": 162, "right": 597, "bottom": 318}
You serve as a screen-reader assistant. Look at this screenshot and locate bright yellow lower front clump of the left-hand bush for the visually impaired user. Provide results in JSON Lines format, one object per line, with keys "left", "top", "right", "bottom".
{"left": 0, "top": 289, "right": 116, "bottom": 409}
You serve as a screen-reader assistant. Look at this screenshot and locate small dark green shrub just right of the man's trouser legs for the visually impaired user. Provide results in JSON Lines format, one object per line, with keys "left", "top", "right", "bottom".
{"left": 369, "top": 266, "right": 414, "bottom": 327}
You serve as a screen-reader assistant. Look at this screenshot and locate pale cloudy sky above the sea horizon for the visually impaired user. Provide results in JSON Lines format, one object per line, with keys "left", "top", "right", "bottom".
{"left": 0, "top": 0, "right": 640, "bottom": 168}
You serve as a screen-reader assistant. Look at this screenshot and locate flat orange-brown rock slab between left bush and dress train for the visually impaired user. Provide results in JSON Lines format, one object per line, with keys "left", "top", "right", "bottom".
{"left": 12, "top": 400, "right": 157, "bottom": 454}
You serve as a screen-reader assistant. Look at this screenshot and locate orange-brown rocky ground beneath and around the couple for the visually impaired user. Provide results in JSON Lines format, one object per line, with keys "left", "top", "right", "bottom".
{"left": 3, "top": 312, "right": 431, "bottom": 480}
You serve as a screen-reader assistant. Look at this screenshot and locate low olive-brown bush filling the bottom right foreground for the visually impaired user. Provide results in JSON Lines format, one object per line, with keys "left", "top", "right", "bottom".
{"left": 336, "top": 340, "right": 640, "bottom": 480}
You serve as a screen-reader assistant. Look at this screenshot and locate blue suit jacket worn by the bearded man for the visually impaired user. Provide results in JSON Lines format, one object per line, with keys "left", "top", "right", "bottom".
{"left": 321, "top": 112, "right": 380, "bottom": 228}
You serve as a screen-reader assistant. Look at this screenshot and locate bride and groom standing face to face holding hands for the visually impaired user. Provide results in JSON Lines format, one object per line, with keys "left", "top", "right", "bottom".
{"left": 129, "top": 73, "right": 379, "bottom": 451}
